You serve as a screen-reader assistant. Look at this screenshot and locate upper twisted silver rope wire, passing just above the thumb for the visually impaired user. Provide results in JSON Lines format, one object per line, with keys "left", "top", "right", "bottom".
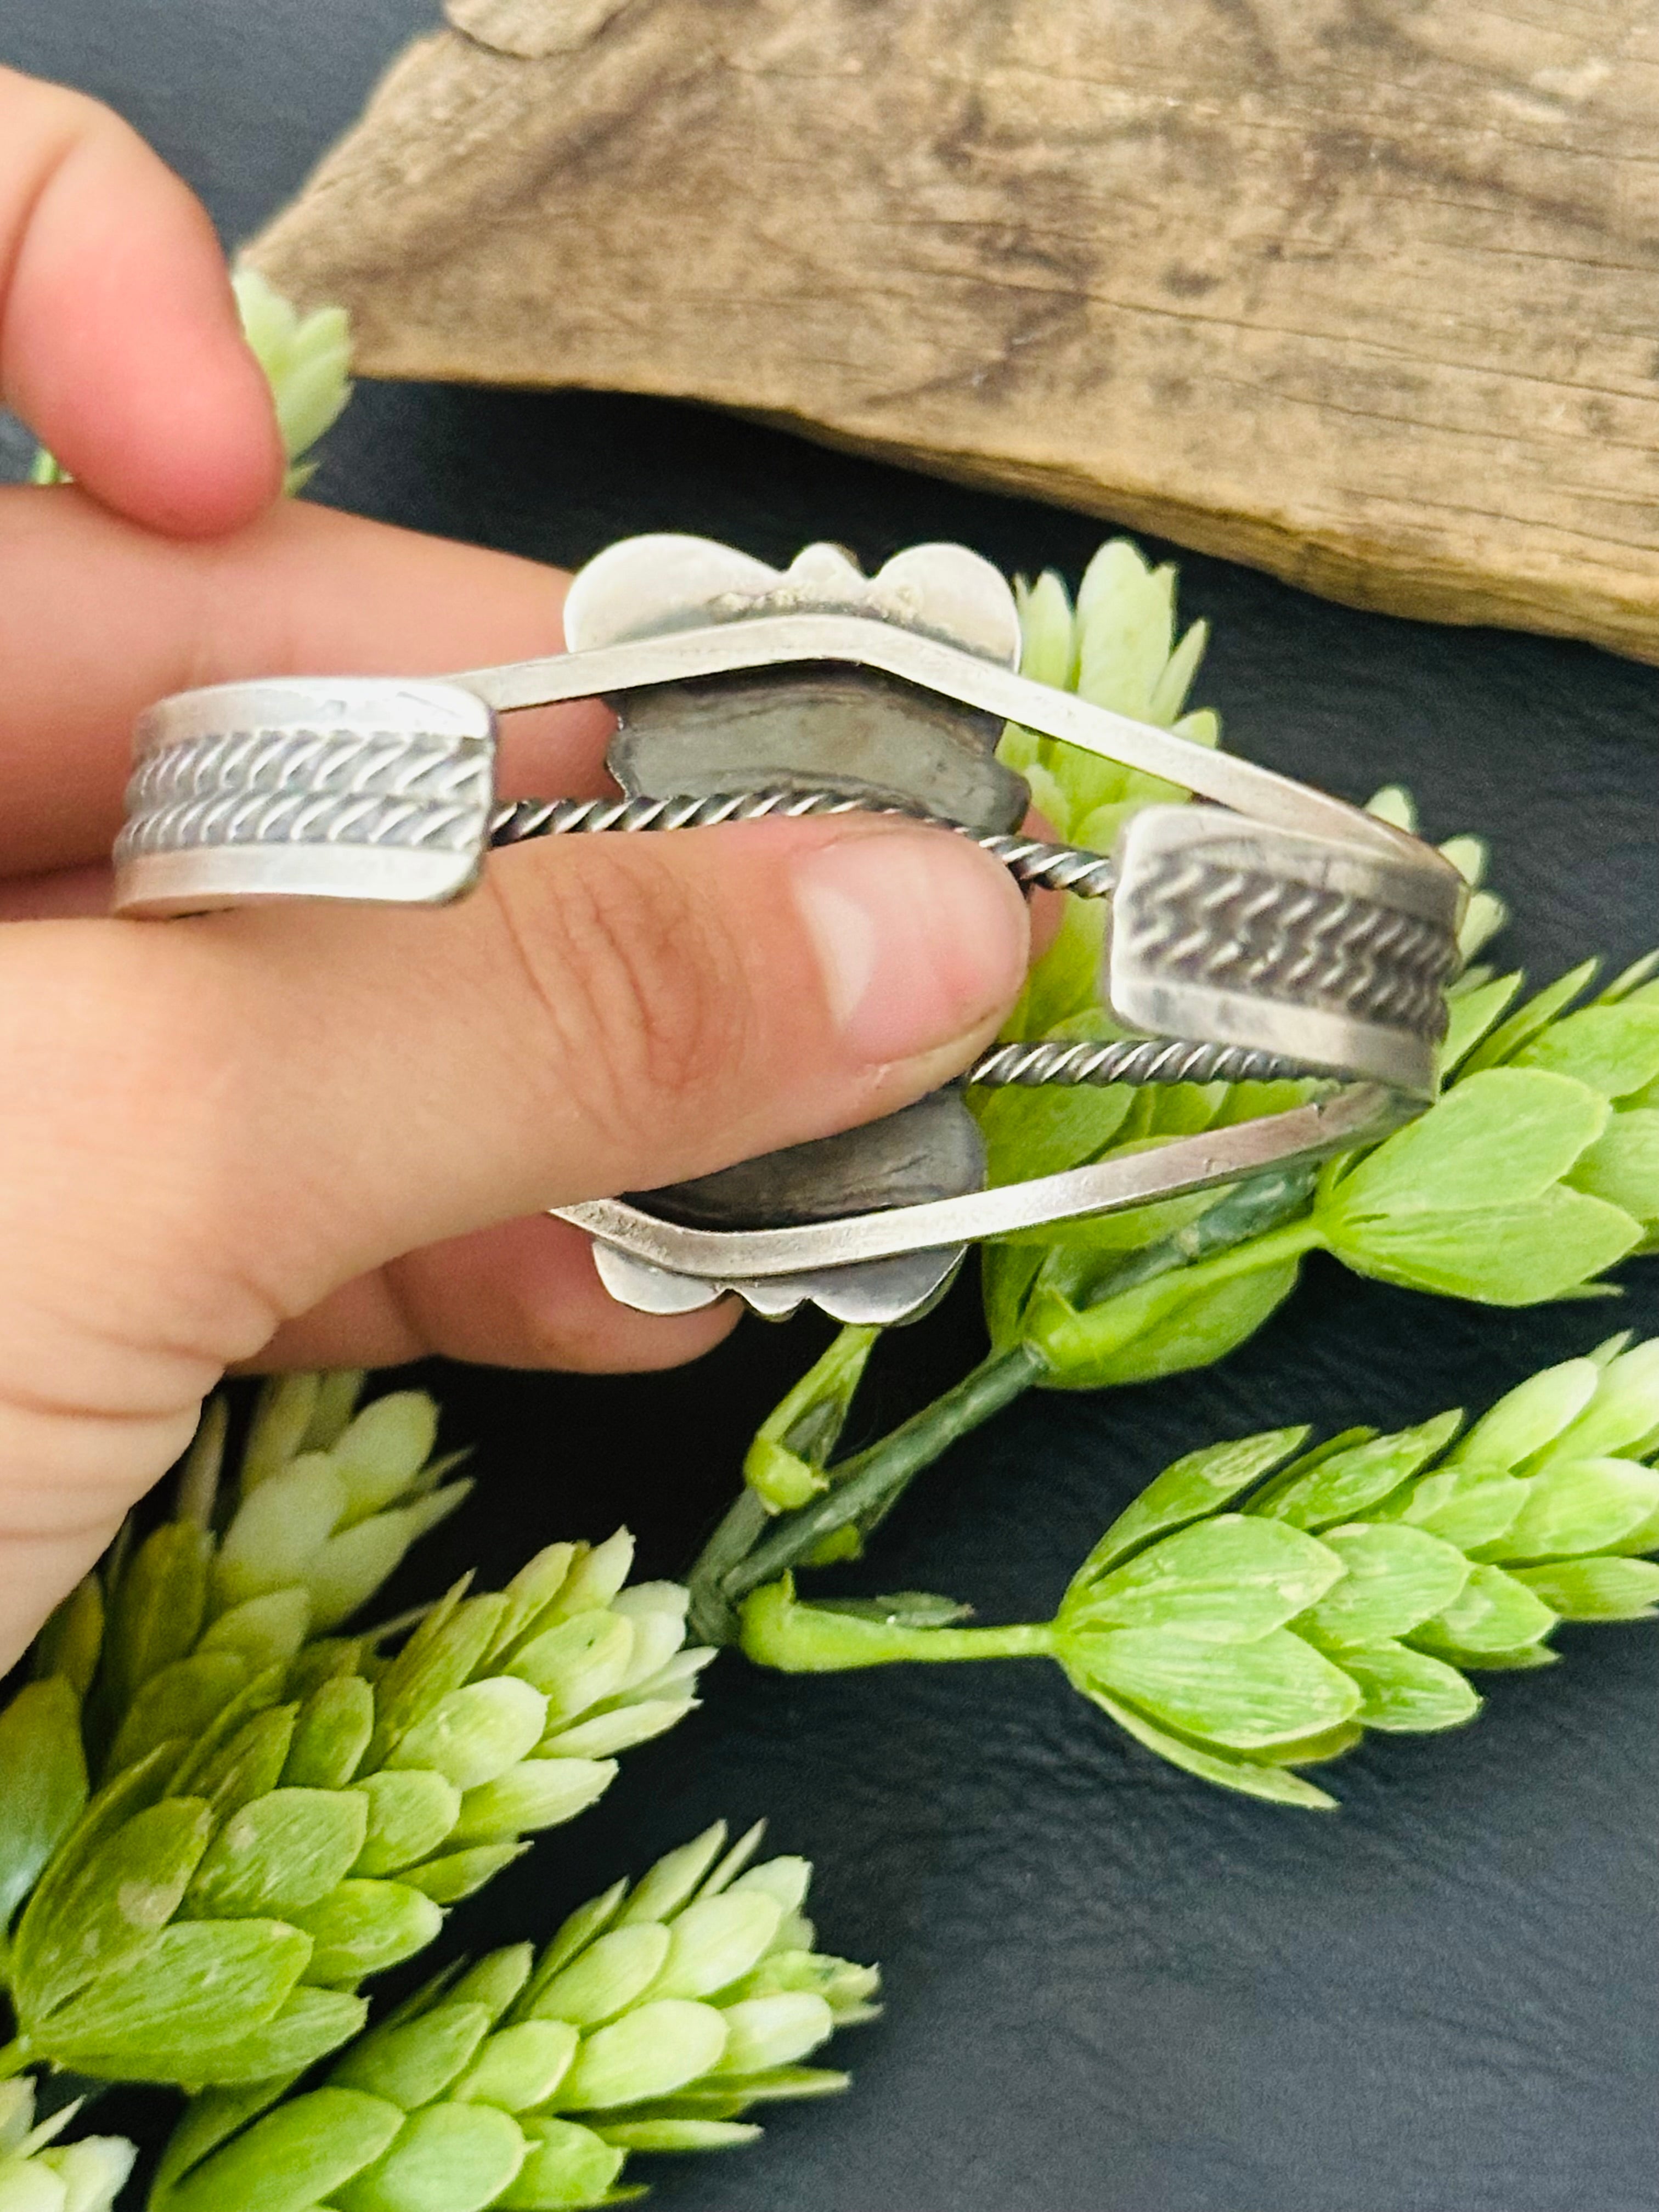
{"left": 489, "top": 789, "right": 1113, "bottom": 898}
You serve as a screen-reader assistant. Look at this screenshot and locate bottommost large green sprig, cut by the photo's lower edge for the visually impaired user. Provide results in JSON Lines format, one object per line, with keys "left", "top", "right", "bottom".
{"left": 150, "top": 1822, "right": 878, "bottom": 2212}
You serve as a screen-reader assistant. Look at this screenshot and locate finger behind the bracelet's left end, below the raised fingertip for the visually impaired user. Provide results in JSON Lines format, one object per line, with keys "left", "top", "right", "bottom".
{"left": 0, "top": 487, "right": 611, "bottom": 880}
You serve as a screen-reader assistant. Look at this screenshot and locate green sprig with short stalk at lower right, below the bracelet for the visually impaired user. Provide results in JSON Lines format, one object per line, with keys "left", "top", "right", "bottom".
{"left": 743, "top": 1338, "right": 1659, "bottom": 1807}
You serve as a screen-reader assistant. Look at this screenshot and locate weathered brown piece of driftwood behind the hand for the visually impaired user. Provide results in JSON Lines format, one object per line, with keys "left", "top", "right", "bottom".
{"left": 252, "top": 0, "right": 1659, "bottom": 659}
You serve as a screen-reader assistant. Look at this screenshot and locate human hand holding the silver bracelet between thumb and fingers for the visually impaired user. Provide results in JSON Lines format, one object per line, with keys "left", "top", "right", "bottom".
{"left": 0, "top": 71, "right": 1029, "bottom": 1666}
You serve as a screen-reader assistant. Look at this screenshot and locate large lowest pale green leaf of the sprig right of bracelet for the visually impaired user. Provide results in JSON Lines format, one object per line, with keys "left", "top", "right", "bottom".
{"left": 1327, "top": 1186, "right": 1641, "bottom": 1305}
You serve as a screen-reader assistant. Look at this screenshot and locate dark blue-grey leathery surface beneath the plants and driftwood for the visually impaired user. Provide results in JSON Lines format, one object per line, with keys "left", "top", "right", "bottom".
{"left": 0, "top": 0, "right": 1659, "bottom": 2212}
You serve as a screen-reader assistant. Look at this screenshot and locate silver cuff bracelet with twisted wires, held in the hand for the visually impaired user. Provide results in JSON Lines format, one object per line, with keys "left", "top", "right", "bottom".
{"left": 115, "top": 535, "right": 1464, "bottom": 1323}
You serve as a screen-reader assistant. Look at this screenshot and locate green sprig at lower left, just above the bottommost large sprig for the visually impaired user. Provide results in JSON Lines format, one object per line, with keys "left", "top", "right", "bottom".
{"left": 7, "top": 1522, "right": 708, "bottom": 2084}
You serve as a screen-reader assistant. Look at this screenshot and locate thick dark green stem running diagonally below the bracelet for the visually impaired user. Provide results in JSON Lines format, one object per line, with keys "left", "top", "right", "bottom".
{"left": 716, "top": 1342, "right": 1048, "bottom": 1633}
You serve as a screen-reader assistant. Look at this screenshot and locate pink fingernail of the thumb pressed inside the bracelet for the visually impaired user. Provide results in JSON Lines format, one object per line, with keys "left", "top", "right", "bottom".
{"left": 797, "top": 830, "right": 1029, "bottom": 1064}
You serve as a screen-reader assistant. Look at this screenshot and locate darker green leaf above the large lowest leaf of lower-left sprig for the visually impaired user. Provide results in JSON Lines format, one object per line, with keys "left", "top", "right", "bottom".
{"left": 11, "top": 1798, "right": 212, "bottom": 2033}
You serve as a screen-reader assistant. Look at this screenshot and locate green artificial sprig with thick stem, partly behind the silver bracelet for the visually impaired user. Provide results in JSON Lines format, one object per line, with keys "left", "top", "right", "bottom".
{"left": 690, "top": 542, "right": 1659, "bottom": 1641}
